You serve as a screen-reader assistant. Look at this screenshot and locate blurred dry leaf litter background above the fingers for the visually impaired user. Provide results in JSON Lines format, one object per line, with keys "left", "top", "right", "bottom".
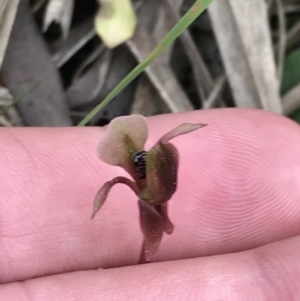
{"left": 0, "top": 0, "right": 300, "bottom": 126}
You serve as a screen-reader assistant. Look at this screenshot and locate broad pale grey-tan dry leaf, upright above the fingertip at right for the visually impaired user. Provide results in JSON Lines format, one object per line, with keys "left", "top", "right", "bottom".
{"left": 209, "top": 0, "right": 282, "bottom": 113}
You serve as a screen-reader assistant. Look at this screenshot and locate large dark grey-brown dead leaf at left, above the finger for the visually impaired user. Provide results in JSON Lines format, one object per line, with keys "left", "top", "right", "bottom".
{"left": 1, "top": 0, "right": 71, "bottom": 126}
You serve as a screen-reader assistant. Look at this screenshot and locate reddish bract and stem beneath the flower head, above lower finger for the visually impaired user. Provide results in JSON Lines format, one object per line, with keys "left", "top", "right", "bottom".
{"left": 139, "top": 200, "right": 164, "bottom": 263}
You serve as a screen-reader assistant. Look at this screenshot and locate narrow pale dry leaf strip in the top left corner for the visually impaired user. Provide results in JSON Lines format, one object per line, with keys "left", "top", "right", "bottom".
{"left": 0, "top": 0, "right": 19, "bottom": 69}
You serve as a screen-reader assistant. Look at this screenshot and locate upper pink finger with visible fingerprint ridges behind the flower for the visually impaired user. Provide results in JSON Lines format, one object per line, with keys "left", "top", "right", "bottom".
{"left": 0, "top": 109, "right": 300, "bottom": 283}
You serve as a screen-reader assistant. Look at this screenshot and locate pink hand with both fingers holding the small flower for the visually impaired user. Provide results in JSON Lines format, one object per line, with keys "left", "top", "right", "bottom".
{"left": 0, "top": 109, "right": 300, "bottom": 301}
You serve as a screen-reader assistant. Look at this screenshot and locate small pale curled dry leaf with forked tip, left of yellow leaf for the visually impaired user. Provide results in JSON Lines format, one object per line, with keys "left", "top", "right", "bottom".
{"left": 43, "top": 0, "right": 74, "bottom": 39}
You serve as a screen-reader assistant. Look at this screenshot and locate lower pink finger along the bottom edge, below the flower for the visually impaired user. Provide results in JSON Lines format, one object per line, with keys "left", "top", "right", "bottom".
{"left": 0, "top": 237, "right": 300, "bottom": 301}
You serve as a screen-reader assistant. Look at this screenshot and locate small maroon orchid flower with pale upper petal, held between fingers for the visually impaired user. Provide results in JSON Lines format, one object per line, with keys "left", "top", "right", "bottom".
{"left": 92, "top": 115, "right": 206, "bottom": 263}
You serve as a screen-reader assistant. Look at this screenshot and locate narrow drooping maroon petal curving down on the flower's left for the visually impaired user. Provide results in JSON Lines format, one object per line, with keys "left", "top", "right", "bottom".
{"left": 91, "top": 177, "right": 138, "bottom": 219}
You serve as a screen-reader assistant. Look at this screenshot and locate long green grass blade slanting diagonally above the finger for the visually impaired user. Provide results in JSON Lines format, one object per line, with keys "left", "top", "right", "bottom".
{"left": 78, "top": 0, "right": 213, "bottom": 126}
